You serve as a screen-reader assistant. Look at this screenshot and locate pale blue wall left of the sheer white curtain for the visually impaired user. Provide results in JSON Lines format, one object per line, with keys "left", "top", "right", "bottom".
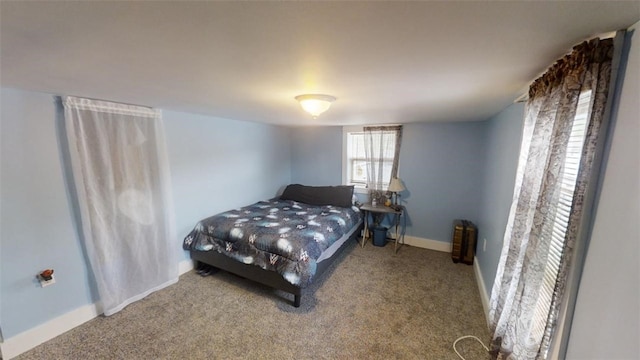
{"left": 0, "top": 89, "right": 94, "bottom": 339}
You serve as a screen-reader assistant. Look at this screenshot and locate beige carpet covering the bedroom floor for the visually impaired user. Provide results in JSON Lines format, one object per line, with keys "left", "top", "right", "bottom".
{"left": 19, "top": 242, "right": 489, "bottom": 359}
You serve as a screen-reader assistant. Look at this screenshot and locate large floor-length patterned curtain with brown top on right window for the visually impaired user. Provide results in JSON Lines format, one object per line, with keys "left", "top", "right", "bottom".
{"left": 489, "top": 39, "right": 613, "bottom": 359}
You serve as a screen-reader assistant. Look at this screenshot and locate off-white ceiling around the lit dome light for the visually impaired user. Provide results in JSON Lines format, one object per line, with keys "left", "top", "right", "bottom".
{"left": 0, "top": 1, "right": 640, "bottom": 126}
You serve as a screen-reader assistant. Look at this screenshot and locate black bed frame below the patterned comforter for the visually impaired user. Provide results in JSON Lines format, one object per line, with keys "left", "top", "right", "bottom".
{"left": 191, "top": 224, "right": 362, "bottom": 307}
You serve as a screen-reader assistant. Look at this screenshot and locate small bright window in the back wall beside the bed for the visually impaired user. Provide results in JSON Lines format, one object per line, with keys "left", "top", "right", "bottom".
{"left": 342, "top": 127, "right": 396, "bottom": 192}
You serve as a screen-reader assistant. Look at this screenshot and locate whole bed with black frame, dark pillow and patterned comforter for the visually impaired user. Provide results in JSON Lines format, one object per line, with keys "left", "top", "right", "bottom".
{"left": 183, "top": 184, "right": 362, "bottom": 307}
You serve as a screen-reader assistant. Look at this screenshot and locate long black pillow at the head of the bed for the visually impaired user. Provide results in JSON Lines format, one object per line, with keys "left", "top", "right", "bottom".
{"left": 280, "top": 184, "right": 353, "bottom": 207}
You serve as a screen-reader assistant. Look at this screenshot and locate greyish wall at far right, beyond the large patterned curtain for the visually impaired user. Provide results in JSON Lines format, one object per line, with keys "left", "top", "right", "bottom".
{"left": 567, "top": 26, "right": 640, "bottom": 359}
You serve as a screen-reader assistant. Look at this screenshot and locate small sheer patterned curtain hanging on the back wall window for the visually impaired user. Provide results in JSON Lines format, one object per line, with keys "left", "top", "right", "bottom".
{"left": 363, "top": 125, "right": 402, "bottom": 201}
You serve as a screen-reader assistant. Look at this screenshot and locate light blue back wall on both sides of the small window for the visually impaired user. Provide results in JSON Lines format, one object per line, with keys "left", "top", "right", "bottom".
{"left": 291, "top": 122, "right": 485, "bottom": 242}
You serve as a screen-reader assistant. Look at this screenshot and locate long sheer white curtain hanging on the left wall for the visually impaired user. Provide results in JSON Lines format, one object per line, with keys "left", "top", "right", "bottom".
{"left": 63, "top": 97, "right": 178, "bottom": 315}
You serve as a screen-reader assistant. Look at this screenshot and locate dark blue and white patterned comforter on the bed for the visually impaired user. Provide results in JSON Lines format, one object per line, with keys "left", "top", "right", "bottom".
{"left": 183, "top": 199, "right": 362, "bottom": 287}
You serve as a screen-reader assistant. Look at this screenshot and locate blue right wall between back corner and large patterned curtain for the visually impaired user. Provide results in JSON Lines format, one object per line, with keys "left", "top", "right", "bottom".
{"left": 476, "top": 103, "right": 524, "bottom": 294}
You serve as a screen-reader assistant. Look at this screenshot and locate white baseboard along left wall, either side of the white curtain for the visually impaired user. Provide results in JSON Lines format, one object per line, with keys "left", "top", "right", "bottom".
{"left": 0, "top": 259, "right": 193, "bottom": 360}
